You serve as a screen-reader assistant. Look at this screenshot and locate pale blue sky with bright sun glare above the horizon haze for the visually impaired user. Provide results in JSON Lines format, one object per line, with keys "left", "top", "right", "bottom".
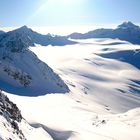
{"left": 0, "top": 0, "right": 140, "bottom": 27}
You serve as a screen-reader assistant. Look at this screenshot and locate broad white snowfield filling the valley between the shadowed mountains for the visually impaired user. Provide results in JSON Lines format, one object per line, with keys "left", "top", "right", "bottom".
{"left": 3, "top": 39, "right": 140, "bottom": 140}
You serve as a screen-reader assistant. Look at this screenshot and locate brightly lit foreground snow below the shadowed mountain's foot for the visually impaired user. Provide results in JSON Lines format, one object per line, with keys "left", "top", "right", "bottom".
{"left": 5, "top": 91, "right": 140, "bottom": 140}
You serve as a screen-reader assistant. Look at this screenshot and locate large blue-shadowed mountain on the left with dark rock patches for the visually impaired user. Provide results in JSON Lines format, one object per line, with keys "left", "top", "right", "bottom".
{"left": 0, "top": 27, "right": 69, "bottom": 96}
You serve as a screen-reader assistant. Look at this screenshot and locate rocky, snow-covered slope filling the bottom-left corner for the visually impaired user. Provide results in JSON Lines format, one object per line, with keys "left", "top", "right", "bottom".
{"left": 0, "top": 91, "right": 52, "bottom": 140}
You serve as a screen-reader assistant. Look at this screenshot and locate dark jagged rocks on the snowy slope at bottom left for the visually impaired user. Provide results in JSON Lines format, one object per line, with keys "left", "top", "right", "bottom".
{"left": 0, "top": 91, "right": 26, "bottom": 140}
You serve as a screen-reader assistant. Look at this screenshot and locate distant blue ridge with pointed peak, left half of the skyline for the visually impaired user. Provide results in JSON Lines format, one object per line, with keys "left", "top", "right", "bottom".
{"left": 0, "top": 26, "right": 76, "bottom": 46}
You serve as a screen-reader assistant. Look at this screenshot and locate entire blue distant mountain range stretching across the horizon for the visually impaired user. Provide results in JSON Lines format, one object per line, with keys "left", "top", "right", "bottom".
{"left": 0, "top": 21, "right": 140, "bottom": 46}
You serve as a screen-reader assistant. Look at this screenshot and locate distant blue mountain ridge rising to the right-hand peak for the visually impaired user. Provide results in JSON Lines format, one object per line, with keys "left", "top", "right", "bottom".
{"left": 68, "top": 22, "right": 140, "bottom": 44}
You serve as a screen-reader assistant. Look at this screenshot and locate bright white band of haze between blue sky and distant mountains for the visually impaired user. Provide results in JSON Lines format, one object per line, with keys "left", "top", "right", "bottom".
{"left": 0, "top": 22, "right": 140, "bottom": 35}
